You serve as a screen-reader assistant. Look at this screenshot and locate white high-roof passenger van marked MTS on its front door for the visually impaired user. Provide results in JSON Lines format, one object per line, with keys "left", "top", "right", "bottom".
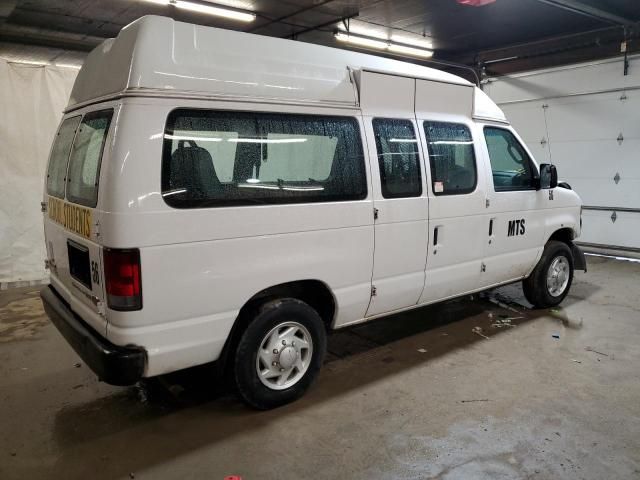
{"left": 37, "top": 17, "right": 585, "bottom": 408}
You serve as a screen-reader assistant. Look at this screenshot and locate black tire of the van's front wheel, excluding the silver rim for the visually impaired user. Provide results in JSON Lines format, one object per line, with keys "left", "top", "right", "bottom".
{"left": 522, "top": 240, "right": 573, "bottom": 308}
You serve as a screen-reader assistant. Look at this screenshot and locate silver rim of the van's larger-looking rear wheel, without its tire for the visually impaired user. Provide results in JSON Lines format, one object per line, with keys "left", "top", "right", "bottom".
{"left": 256, "top": 322, "right": 313, "bottom": 390}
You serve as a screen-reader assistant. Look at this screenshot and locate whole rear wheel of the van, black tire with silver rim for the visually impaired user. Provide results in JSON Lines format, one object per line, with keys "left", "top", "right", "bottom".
{"left": 234, "top": 298, "right": 327, "bottom": 410}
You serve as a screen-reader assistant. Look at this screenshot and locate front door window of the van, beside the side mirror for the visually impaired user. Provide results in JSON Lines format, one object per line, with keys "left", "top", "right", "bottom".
{"left": 484, "top": 127, "right": 535, "bottom": 192}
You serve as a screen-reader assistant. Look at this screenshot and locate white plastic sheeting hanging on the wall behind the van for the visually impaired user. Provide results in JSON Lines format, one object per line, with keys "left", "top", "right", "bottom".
{"left": 0, "top": 59, "right": 78, "bottom": 284}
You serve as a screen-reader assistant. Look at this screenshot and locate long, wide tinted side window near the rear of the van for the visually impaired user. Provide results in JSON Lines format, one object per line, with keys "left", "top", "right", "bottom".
{"left": 162, "top": 109, "right": 367, "bottom": 208}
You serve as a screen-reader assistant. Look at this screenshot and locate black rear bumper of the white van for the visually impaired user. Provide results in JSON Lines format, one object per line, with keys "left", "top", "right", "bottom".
{"left": 40, "top": 286, "right": 147, "bottom": 386}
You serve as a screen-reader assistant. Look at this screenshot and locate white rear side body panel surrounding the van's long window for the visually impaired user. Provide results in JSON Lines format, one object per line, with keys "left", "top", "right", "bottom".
{"left": 102, "top": 100, "right": 373, "bottom": 376}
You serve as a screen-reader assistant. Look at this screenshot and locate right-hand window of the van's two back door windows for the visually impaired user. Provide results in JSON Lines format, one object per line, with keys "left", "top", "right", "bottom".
{"left": 67, "top": 110, "right": 113, "bottom": 207}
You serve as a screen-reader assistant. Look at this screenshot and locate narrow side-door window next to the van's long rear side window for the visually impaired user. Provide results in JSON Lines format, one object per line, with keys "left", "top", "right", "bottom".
{"left": 372, "top": 118, "right": 422, "bottom": 198}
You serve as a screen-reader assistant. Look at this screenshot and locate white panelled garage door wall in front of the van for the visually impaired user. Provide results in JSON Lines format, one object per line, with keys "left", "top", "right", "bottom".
{"left": 484, "top": 56, "right": 640, "bottom": 252}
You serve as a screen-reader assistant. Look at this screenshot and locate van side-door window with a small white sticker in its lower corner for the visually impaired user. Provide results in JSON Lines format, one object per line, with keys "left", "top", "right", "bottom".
{"left": 424, "top": 122, "right": 477, "bottom": 195}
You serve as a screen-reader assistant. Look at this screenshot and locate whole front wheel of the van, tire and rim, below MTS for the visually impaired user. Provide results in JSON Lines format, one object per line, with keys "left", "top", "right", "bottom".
{"left": 522, "top": 240, "right": 573, "bottom": 308}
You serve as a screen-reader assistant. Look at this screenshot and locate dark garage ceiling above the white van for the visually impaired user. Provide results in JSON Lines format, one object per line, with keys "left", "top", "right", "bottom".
{"left": 0, "top": 0, "right": 640, "bottom": 76}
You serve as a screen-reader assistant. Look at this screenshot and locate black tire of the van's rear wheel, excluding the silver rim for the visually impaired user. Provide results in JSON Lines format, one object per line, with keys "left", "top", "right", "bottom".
{"left": 234, "top": 298, "right": 327, "bottom": 410}
